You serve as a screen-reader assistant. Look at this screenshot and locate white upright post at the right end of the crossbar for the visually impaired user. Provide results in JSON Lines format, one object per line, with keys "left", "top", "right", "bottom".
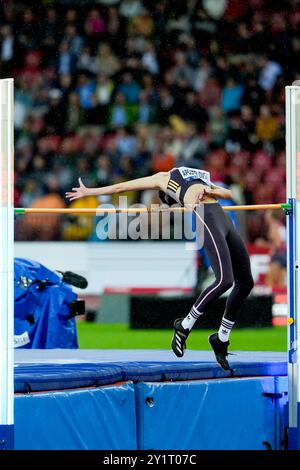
{"left": 286, "top": 86, "right": 300, "bottom": 449}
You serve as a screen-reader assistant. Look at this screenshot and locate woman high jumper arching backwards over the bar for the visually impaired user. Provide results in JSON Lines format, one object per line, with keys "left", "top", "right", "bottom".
{"left": 66, "top": 167, "right": 253, "bottom": 370}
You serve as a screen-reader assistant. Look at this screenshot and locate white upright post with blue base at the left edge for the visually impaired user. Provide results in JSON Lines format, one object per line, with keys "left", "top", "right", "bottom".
{"left": 0, "top": 78, "right": 14, "bottom": 449}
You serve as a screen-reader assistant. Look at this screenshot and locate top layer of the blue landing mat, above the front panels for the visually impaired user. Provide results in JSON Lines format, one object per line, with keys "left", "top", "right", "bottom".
{"left": 15, "top": 349, "right": 287, "bottom": 393}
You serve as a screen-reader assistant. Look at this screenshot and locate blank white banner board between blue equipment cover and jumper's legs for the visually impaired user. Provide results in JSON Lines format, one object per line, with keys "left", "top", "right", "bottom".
{"left": 15, "top": 241, "right": 197, "bottom": 295}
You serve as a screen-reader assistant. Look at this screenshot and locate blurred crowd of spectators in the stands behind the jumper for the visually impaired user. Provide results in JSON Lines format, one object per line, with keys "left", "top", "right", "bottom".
{"left": 0, "top": 0, "right": 300, "bottom": 248}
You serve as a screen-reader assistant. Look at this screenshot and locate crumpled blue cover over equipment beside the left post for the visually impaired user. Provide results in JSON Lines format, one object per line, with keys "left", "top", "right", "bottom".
{"left": 14, "top": 258, "right": 78, "bottom": 349}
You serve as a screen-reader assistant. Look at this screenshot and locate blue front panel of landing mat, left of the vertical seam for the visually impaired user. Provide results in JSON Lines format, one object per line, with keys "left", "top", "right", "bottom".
{"left": 15, "top": 383, "right": 137, "bottom": 450}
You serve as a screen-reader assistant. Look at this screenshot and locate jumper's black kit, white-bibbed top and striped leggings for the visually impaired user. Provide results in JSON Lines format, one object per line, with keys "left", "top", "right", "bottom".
{"left": 160, "top": 167, "right": 253, "bottom": 322}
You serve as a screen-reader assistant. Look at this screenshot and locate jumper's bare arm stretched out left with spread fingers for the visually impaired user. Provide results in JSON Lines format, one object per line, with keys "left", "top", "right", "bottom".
{"left": 66, "top": 173, "right": 168, "bottom": 201}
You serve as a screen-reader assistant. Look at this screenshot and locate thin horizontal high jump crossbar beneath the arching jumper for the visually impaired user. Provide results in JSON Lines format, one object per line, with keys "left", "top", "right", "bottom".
{"left": 14, "top": 203, "right": 292, "bottom": 215}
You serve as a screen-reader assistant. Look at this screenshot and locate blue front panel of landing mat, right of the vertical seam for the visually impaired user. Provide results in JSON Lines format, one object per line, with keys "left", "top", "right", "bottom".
{"left": 136, "top": 377, "right": 286, "bottom": 450}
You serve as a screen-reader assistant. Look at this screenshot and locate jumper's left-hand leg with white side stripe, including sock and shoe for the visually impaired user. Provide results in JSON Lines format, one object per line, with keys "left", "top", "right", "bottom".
{"left": 172, "top": 208, "right": 234, "bottom": 357}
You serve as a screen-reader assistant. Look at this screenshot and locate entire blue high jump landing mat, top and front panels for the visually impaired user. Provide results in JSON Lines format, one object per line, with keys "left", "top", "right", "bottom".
{"left": 15, "top": 349, "right": 287, "bottom": 450}
